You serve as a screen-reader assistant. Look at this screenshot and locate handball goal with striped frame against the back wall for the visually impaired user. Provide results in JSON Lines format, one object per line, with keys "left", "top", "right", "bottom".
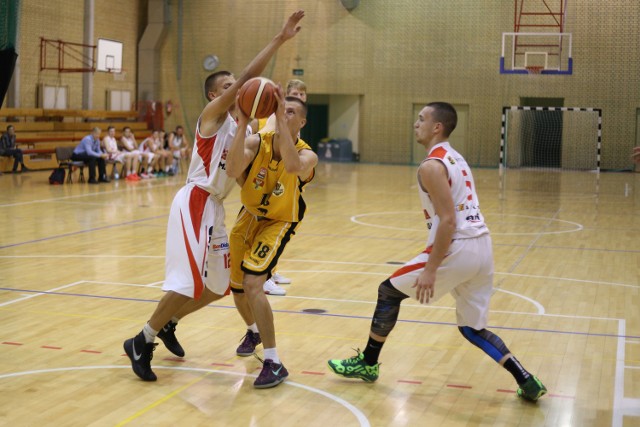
{"left": 500, "top": 106, "right": 602, "bottom": 172}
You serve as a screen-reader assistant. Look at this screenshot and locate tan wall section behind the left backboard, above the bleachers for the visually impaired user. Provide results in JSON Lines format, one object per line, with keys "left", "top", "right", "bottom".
{"left": 18, "top": 0, "right": 141, "bottom": 110}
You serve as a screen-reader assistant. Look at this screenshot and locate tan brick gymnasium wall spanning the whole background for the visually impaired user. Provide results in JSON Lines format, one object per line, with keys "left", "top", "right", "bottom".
{"left": 15, "top": 0, "right": 640, "bottom": 169}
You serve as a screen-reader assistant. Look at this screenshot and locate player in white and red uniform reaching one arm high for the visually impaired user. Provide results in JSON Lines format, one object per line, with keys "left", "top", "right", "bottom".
{"left": 124, "top": 10, "right": 304, "bottom": 381}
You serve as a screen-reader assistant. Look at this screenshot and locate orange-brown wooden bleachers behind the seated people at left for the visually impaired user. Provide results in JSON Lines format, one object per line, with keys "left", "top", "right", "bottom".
{"left": 0, "top": 108, "right": 148, "bottom": 172}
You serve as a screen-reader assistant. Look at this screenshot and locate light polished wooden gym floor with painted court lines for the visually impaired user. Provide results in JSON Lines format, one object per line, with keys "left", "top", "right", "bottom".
{"left": 0, "top": 163, "right": 640, "bottom": 427}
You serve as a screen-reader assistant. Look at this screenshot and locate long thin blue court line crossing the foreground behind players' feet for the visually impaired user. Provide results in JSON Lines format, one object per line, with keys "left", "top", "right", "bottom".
{"left": 0, "top": 288, "right": 640, "bottom": 339}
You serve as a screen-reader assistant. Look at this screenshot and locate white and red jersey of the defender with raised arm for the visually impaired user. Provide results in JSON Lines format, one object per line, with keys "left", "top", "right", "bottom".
{"left": 187, "top": 114, "right": 251, "bottom": 200}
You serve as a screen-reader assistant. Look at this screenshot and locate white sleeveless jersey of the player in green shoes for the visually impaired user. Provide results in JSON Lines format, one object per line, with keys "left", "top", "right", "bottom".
{"left": 418, "top": 142, "right": 489, "bottom": 247}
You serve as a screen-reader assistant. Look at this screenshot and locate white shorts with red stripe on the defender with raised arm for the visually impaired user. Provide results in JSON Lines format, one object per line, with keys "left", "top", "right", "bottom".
{"left": 162, "top": 184, "right": 231, "bottom": 299}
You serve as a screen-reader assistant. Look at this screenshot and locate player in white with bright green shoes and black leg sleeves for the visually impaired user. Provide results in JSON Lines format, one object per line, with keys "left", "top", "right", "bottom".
{"left": 328, "top": 102, "right": 547, "bottom": 401}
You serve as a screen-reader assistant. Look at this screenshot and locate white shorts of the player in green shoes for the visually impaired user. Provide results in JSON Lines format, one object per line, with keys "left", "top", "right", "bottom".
{"left": 390, "top": 234, "right": 493, "bottom": 330}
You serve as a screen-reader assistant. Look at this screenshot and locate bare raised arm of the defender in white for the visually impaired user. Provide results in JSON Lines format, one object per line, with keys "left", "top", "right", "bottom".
{"left": 200, "top": 10, "right": 304, "bottom": 135}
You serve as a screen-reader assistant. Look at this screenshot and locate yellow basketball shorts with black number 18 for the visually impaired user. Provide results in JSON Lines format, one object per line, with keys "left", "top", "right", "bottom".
{"left": 229, "top": 208, "right": 299, "bottom": 289}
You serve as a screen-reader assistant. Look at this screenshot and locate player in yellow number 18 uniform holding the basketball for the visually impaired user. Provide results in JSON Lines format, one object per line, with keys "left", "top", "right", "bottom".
{"left": 227, "top": 92, "right": 318, "bottom": 388}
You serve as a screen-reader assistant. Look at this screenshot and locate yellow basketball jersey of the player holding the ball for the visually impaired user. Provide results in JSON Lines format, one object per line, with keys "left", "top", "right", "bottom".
{"left": 240, "top": 132, "right": 315, "bottom": 222}
